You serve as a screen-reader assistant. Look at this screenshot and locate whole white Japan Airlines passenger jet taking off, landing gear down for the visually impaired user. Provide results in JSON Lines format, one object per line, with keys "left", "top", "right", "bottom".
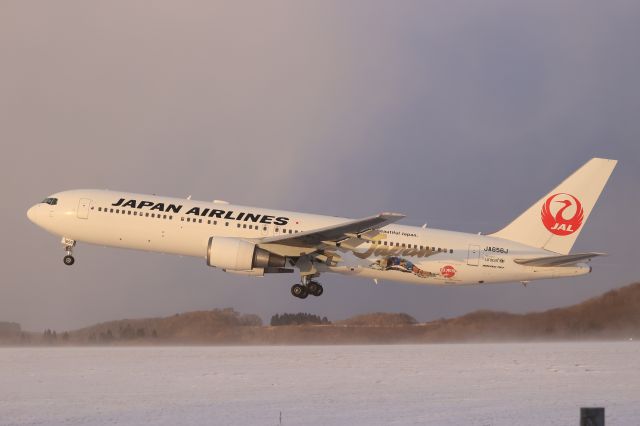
{"left": 27, "top": 158, "right": 617, "bottom": 299}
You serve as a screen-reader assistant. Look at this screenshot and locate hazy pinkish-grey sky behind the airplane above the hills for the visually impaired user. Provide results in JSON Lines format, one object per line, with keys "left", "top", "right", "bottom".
{"left": 0, "top": 0, "right": 640, "bottom": 330}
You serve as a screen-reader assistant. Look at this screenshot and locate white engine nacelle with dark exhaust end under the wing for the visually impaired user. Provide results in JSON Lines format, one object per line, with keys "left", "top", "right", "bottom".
{"left": 207, "top": 237, "right": 285, "bottom": 271}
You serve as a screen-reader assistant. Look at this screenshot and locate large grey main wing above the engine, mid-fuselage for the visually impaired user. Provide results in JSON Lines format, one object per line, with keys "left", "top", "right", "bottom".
{"left": 259, "top": 213, "right": 405, "bottom": 249}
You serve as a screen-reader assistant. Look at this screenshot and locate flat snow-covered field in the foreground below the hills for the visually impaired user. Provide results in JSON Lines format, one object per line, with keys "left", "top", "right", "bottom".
{"left": 0, "top": 342, "right": 640, "bottom": 425}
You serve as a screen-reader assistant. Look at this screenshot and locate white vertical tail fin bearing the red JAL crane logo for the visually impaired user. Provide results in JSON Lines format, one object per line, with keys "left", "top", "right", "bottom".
{"left": 492, "top": 158, "right": 617, "bottom": 254}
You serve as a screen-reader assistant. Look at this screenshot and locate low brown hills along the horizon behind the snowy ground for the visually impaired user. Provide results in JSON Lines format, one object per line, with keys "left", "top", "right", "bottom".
{"left": 5, "top": 283, "right": 640, "bottom": 344}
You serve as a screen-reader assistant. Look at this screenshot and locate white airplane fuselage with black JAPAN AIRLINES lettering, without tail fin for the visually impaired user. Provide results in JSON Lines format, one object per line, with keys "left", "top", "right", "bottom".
{"left": 28, "top": 190, "right": 590, "bottom": 285}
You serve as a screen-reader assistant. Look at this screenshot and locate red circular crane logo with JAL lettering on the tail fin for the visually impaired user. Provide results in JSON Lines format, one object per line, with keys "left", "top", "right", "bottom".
{"left": 541, "top": 192, "right": 584, "bottom": 236}
